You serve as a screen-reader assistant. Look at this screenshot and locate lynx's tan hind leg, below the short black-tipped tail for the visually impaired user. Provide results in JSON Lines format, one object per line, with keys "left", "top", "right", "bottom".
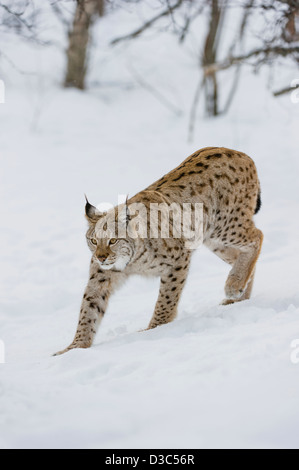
{"left": 213, "top": 226, "right": 263, "bottom": 305}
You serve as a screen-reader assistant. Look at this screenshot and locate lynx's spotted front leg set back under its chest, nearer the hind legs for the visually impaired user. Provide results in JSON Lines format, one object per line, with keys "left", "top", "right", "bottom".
{"left": 147, "top": 254, "right": 190, "bottom": 330}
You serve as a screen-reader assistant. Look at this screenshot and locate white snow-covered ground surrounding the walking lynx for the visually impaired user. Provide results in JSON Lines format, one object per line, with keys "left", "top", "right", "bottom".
{"left": 0, "top": 4, "right": 299, "bottom": 448}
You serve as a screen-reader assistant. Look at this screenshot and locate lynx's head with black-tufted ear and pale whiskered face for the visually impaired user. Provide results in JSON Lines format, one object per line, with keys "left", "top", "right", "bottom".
{"left": 85, "top": 199, "right": 135, "bottom": 271}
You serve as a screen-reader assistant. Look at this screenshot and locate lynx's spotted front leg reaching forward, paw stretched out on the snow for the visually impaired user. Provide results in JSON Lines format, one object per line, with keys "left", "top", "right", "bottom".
{"left": 54, "top": 260, "right": 120, "bottom": 356}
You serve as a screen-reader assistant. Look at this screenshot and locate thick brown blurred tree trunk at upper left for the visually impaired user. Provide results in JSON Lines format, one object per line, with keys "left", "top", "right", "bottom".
{"left": 64, "top": 0, "right": 104, "bottom": 90}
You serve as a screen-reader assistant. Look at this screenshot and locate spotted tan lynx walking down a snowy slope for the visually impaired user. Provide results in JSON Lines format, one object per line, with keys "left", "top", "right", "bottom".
{"left": 56, "top": 147, "right": 263, "bottom": 354}
